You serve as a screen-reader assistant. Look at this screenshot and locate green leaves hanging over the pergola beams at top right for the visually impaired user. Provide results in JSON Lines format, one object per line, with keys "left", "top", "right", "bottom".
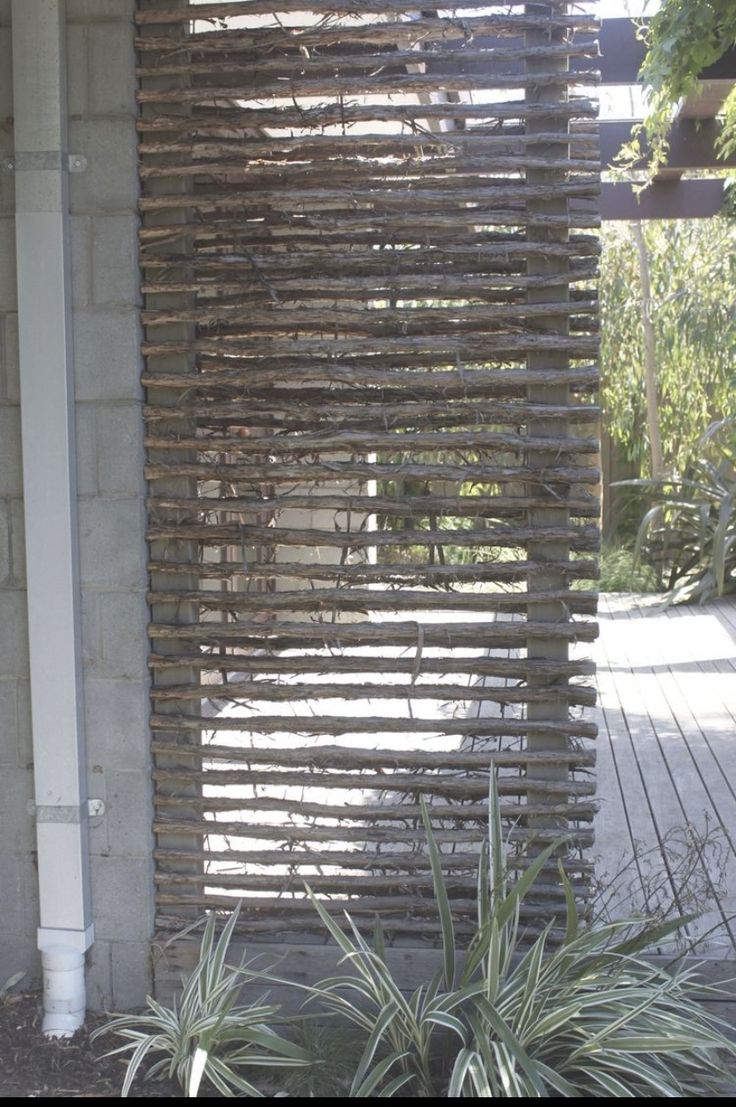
{"left": 622, "top": 0, "right": 736, "bottom": 174}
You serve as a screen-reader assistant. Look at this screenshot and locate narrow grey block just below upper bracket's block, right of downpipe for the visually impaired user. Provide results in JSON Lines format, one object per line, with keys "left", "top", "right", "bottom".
{"left": 92, "top": 215, "right": 141, "bottom": 306}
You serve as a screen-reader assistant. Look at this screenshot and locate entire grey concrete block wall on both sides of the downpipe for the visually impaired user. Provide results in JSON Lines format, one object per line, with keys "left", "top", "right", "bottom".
{"left": 0, "top": 0, "right": 153, "bottom": 1010}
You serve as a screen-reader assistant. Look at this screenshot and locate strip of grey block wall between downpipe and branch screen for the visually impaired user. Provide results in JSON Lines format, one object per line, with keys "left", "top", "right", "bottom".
{"left": 66, "top": 0, "right": 153, "bottom": 1010}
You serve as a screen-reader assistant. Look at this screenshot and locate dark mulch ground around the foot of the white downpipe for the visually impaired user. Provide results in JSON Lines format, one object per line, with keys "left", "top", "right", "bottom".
{"left": 0, "top": 993, "right": 182, "bottom": 1098}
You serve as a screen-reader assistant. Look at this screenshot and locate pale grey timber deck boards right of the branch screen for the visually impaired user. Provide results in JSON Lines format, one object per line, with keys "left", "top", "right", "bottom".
{"left": 594, "top": 596, "right": 736, "bottom": 958}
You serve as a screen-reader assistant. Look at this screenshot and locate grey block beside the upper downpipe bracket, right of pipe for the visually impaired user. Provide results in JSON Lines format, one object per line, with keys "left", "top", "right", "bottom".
{"left": 69, "top": 116, "right": 138, "bottom": 215}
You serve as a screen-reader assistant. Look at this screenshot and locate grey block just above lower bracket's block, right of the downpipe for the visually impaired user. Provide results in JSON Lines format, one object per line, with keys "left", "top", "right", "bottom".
{"left": 84, "top": 677, "right": 151, "bottom": 772}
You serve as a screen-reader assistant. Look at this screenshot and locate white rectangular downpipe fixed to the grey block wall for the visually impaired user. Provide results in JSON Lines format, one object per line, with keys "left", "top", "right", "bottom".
{"left": 12, "top": 0, "right": 94, "bottom": 1036}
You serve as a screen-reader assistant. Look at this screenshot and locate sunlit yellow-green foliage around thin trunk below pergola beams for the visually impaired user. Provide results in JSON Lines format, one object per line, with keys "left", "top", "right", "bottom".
{"left": 600, "top": 218, "right": 736, "bottom": 475}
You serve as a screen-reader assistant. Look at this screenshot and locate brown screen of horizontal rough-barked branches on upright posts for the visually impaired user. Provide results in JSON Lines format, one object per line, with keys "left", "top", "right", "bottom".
{"left": 137, "top": 0, "right": 599, "bottom": 938}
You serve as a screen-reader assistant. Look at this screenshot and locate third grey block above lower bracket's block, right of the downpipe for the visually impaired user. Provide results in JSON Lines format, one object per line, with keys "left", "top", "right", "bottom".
{"left": 79, "top": 498, "right": 146, "bottom": 590}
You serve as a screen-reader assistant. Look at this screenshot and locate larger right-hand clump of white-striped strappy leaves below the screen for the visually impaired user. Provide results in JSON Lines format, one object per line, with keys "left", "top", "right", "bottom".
{"left": 294, "top": 795, "right": 735, "bottom": 1098}
